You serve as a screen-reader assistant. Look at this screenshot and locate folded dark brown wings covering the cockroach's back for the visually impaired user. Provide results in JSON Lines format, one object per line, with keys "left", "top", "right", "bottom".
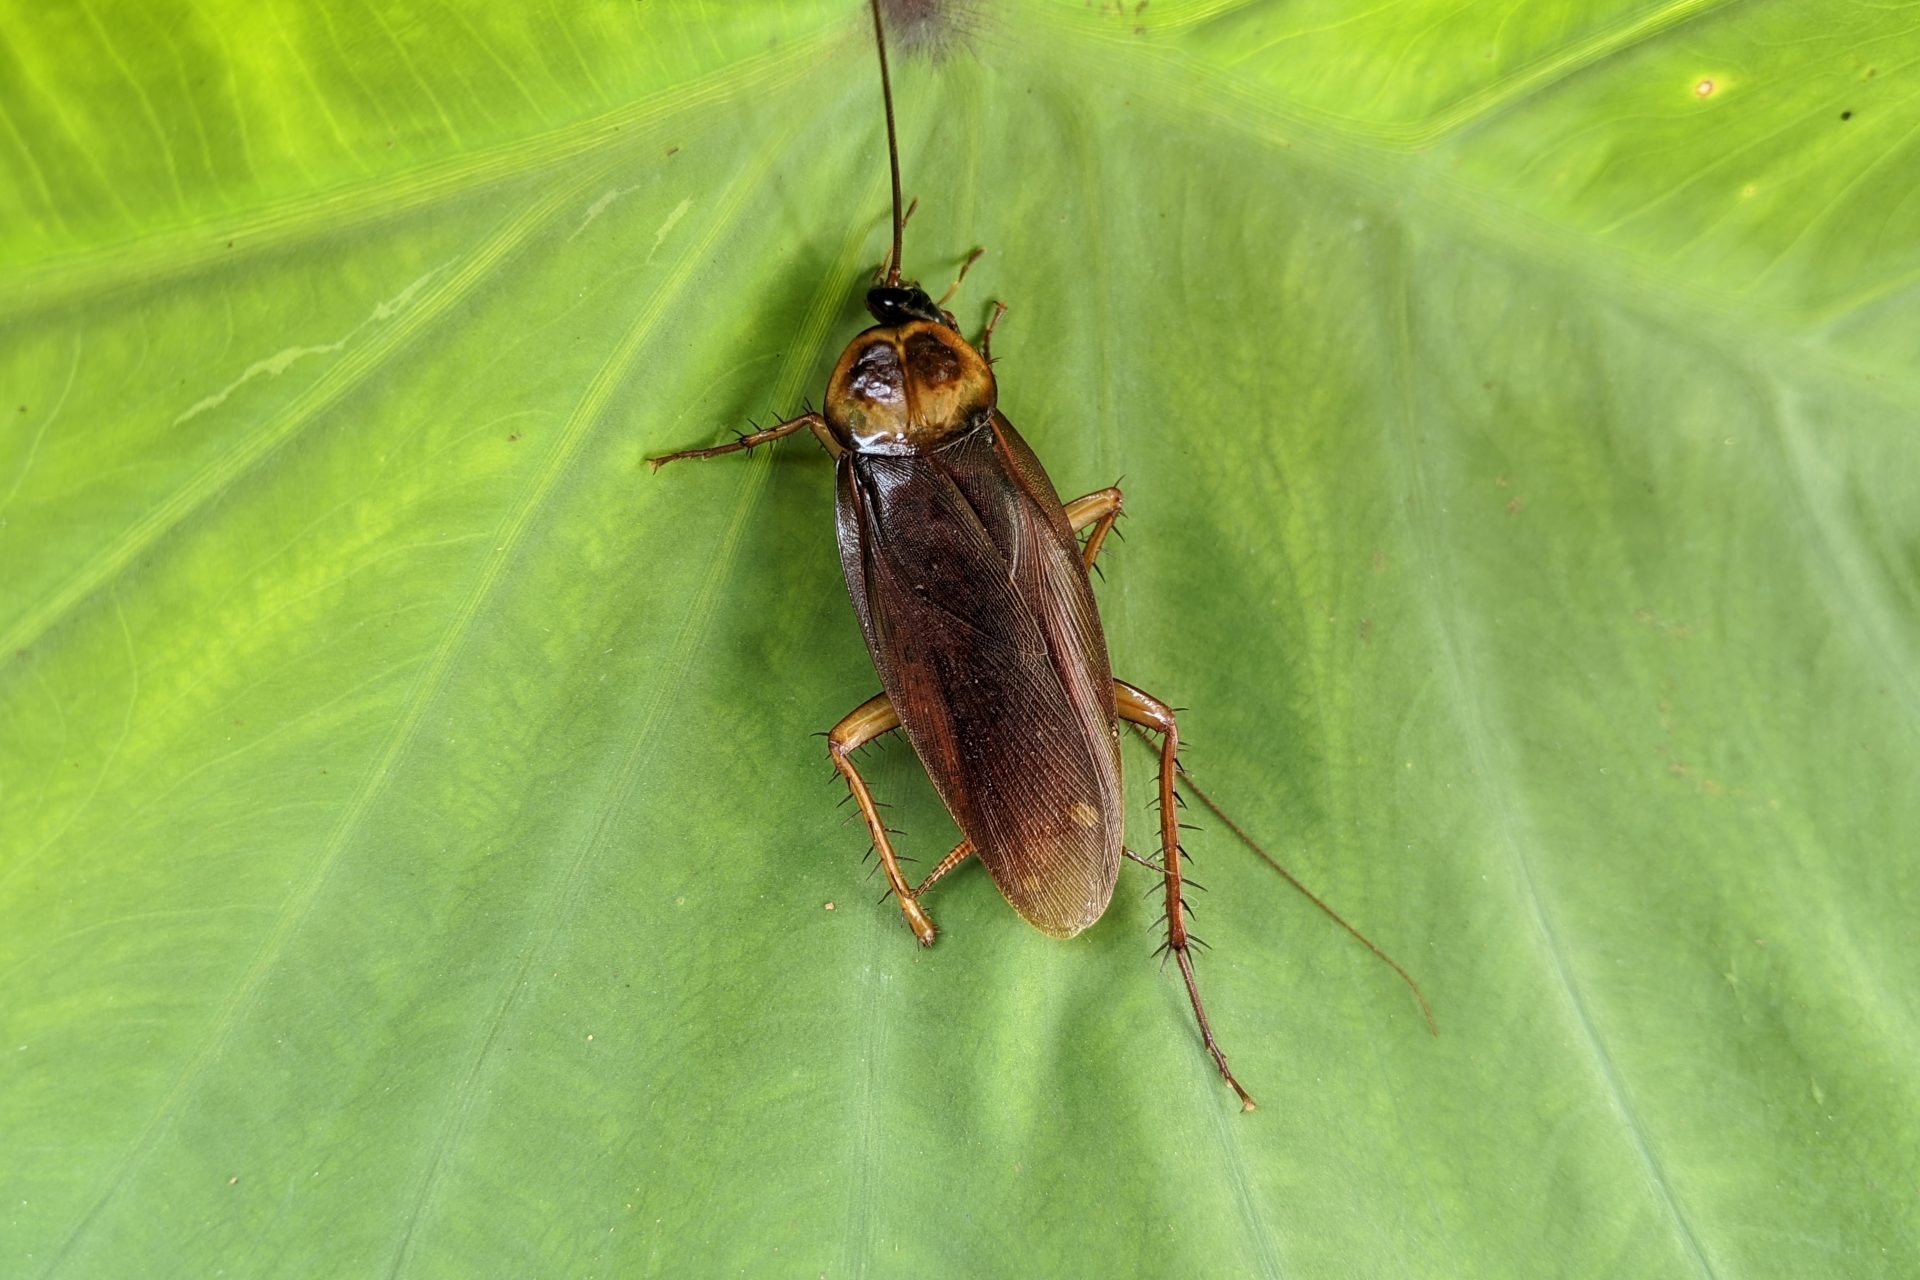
{"left": 839, "top": 413, "right": 1121, "bottom": 936}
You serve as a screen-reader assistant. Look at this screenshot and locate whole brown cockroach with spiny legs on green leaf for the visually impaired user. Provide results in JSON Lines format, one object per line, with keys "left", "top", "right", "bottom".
{"left": 649, "top": 0, "right": 1425, "bottom": 1111}
